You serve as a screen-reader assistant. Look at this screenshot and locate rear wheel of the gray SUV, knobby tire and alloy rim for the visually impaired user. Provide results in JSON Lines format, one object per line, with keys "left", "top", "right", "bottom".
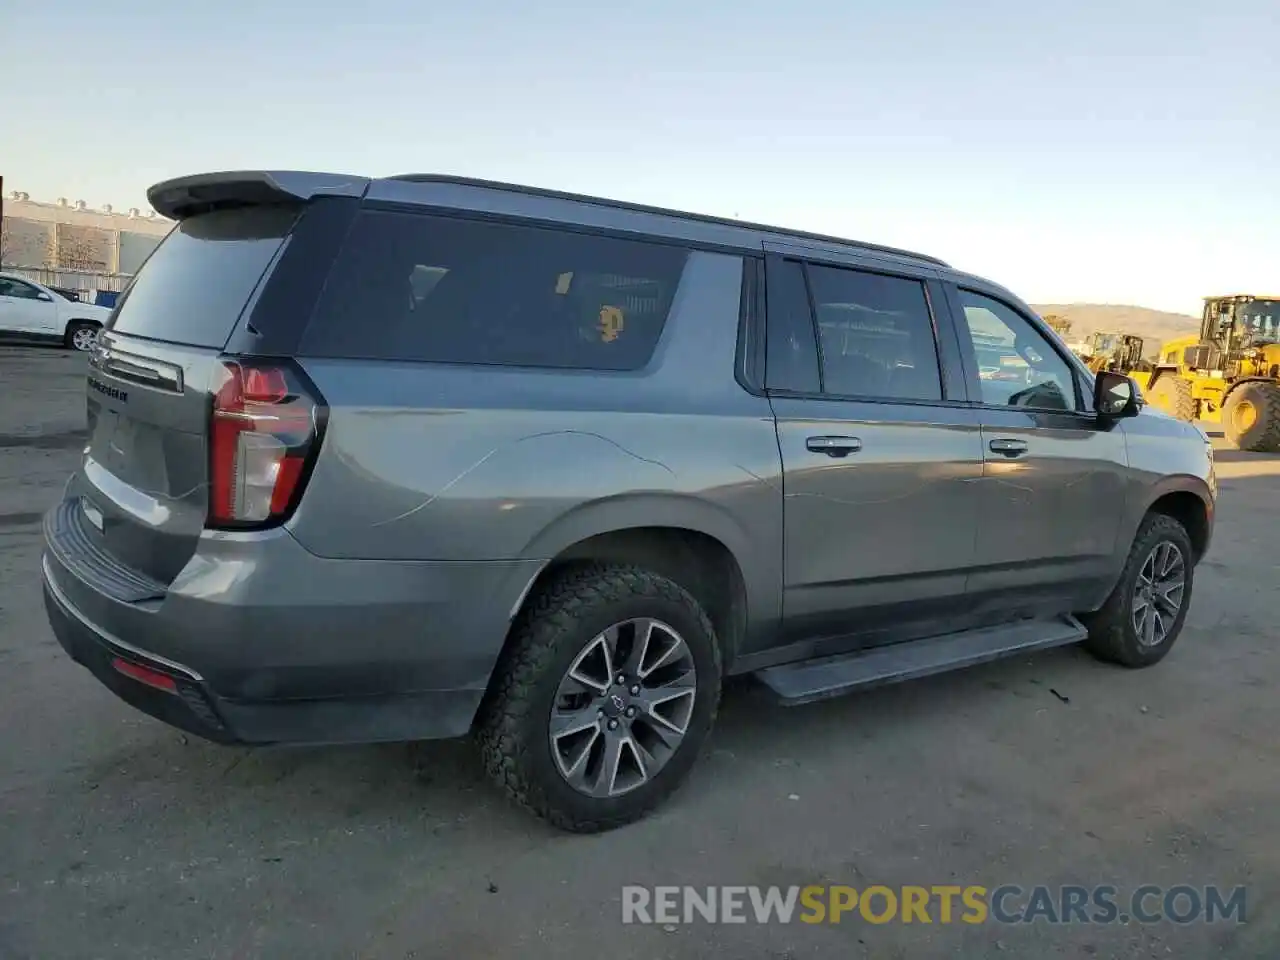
{"left": 477, "top": 566, "right": 721, "bottom": 833}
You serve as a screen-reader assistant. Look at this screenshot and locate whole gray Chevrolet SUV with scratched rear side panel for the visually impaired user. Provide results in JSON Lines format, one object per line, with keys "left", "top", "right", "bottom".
{"left": 42, "top": 172, "right": 1216, "bottom": 831}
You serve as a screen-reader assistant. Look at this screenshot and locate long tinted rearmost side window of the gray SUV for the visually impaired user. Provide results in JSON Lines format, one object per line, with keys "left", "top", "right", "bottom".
{"left": 301, "top": 211, "right": 687, "bottom": 370}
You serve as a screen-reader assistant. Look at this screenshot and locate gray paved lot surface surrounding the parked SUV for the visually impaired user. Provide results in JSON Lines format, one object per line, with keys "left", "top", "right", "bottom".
{"left": 0, "top": 348, "right": 1280, "bottom": 960}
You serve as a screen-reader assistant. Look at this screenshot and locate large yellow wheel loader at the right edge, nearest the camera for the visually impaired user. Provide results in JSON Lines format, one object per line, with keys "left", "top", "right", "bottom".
{"left": 1130, "top": 293, "right": 1280, "bottom": 452}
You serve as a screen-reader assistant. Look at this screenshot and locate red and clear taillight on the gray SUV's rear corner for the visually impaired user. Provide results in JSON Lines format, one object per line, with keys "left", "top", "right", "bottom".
{"left": 209, "top": 360, "right": 324, "bottom": 527}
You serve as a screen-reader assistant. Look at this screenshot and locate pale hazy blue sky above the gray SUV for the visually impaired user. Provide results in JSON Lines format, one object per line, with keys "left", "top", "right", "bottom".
{"left": 0, "top": 0, "right": 1280, "bottom": 312}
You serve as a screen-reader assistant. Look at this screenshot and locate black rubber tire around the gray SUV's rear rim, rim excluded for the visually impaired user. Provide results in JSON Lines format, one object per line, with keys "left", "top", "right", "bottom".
{"left": 476, "top": 564, "right": 721, "bottom": 833}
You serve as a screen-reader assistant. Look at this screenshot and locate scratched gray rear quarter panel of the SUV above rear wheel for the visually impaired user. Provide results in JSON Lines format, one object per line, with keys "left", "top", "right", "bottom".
{"left": 289, "top": 252, "right": 782, "bottom": 632}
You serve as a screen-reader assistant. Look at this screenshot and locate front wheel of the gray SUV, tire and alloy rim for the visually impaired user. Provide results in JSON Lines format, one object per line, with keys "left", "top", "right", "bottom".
{"left": 1080, "top": 513, "right": 1196, "bottom": 667}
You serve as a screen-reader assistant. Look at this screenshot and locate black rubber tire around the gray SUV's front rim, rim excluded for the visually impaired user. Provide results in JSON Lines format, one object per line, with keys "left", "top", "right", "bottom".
{"left": 1080, "top": 513, "right": 1196, "bottom": 667}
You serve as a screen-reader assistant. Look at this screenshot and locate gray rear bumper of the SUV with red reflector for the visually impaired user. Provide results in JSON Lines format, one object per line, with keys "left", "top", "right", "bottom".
{"left": 42, "top": 507, "right": 538, "bottom": 744}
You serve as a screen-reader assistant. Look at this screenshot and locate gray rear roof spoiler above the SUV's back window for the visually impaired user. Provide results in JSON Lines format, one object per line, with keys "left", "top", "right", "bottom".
{"left": 147, "top": 170, "right": 370, "bottom": 220}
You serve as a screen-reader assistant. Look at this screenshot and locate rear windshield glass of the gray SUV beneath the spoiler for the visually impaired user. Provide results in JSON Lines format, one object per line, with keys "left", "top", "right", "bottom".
{"left": 111, "top": 206, "right": 298, "bottom": 348}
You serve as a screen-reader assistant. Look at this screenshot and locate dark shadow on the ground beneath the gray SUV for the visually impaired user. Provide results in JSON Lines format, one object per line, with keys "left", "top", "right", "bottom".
{"left": 74, "top": 648, "right": 1111, "bottom": 847}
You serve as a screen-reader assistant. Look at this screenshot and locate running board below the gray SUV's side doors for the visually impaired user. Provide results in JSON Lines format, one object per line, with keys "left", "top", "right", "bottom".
{"left": 755, "top": 617, "right": 1088, "bottom": 707}
